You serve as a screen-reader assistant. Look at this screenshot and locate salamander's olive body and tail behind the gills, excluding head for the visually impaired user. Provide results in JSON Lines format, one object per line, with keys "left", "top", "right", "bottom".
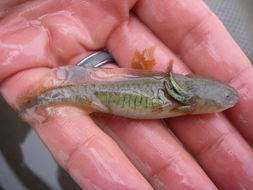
{"left": 20, "top": 71, "right": 180, "bottom": 119}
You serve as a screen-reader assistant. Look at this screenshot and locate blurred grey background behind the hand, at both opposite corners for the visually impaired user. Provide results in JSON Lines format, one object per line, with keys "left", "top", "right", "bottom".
{"left": 0, "top": 0, "right": 253, "bottom": 190}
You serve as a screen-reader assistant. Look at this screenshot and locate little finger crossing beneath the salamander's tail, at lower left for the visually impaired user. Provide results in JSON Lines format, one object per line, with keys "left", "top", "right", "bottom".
{"left": 1, "top": 69, "right": 152, "bottom": 189}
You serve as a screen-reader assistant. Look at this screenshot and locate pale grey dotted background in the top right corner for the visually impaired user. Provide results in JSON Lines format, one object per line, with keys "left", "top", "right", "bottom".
{"left": 205, "top": 0, "right": 253, "bottom": 60}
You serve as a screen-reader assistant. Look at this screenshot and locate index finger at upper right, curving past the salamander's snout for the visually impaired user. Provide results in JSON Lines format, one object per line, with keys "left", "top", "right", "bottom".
{"left": 135, "top": 0, "right": 253, "bottom": 144}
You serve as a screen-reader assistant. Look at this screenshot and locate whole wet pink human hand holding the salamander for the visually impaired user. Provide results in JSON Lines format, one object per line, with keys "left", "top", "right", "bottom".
{"left": 0, "top": 0, "right": 253, "bottom": 190}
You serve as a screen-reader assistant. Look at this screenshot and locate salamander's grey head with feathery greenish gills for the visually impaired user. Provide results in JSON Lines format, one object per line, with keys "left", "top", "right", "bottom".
{"left": 167, "top": 73, "right": 238, "bottom": 114}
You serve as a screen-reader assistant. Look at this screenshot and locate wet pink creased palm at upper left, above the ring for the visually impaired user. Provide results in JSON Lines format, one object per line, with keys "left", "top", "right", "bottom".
{"left": 0, "top": 0, "right": 134, "bottom": 82}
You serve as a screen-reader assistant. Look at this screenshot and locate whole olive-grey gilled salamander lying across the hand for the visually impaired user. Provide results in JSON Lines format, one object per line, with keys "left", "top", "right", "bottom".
{"left": 18, "top": 66, "right": 238, "bottom": 119}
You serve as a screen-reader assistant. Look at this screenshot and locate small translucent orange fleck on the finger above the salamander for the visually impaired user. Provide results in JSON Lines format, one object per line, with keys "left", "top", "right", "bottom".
{"left": 132, "top": 46, "right": 156, "bottom": 70}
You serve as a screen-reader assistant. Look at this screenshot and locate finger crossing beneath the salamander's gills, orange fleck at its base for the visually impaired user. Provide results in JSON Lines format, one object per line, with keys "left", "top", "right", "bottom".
{"left": 108, "top": 16, "right": 253, "bottom": 189}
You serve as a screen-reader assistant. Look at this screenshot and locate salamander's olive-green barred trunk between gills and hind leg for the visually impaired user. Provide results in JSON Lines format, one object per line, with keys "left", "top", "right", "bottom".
{"left": 87, "top": 81, "right": 176, "bottom": 118}
